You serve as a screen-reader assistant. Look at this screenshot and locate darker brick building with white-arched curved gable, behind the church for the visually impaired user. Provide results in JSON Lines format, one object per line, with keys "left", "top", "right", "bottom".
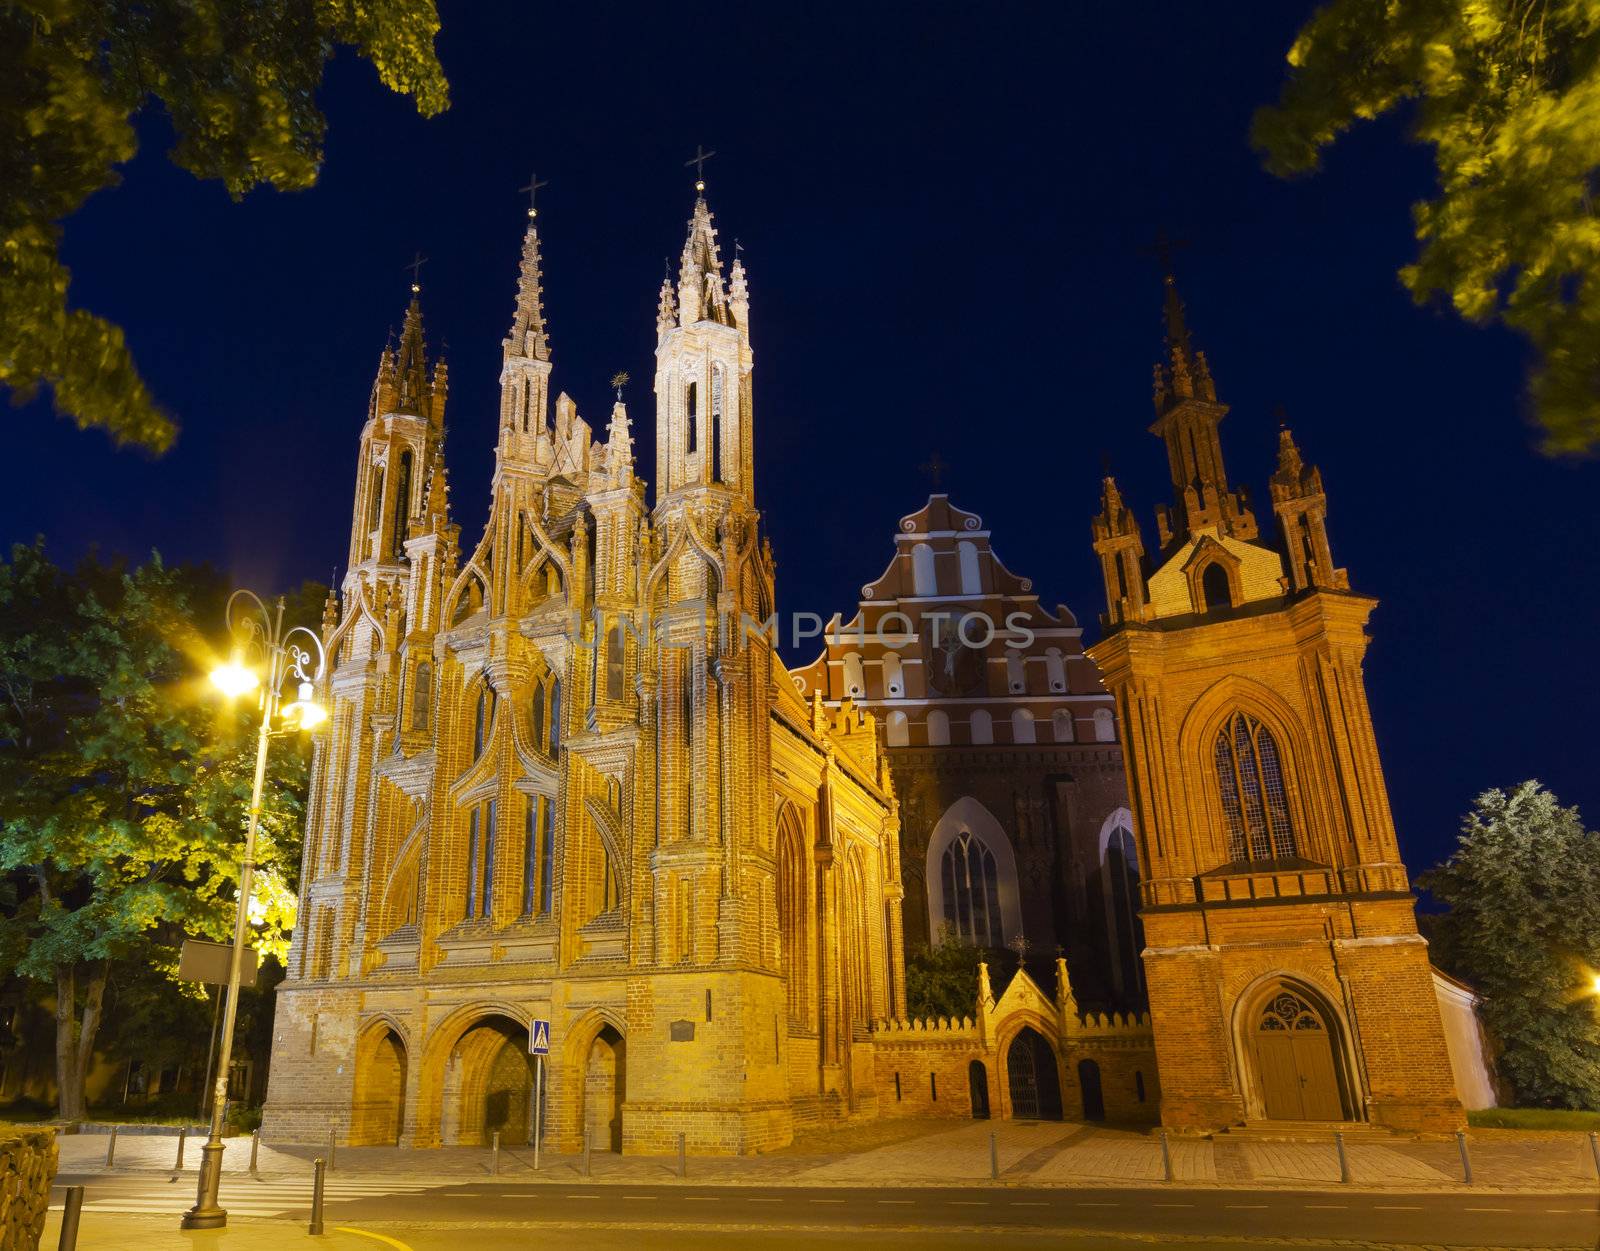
{"left": 794, "top": 494, "right": 1144, "bottom": 1008}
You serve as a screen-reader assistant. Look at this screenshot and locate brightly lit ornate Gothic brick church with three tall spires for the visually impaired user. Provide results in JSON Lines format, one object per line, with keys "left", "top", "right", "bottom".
{"left": 266, "top": 188, "right": 904, "bottom": 1152}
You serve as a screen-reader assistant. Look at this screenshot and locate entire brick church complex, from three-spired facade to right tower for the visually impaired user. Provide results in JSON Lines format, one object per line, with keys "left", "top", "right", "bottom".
{"left": 262, "top": 182, "right": 1461, "bottom": 1153}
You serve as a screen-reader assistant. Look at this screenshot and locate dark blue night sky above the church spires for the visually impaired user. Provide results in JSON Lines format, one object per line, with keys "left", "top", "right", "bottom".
{"left": 0, "top": 0, "right": 1600, "bottom": 869}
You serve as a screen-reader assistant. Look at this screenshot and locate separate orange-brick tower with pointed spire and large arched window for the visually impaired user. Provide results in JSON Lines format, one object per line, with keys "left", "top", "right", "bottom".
{"left": 1090, "top": 275, "right": 1462, "bottom": 1131}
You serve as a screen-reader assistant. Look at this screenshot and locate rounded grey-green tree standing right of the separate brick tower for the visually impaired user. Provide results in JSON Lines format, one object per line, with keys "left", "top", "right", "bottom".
{"left": 1419, "top": 781, "right": 1600, "bottom": 1109}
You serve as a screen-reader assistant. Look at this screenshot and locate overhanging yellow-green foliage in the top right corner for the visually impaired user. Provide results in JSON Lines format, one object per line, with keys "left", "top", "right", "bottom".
{"left": 1251, "top": 0, "right": 1600, "bottom": 451}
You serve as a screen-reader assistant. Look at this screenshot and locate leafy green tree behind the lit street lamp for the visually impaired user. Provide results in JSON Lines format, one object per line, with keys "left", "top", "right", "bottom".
{"left": 0, "top": 542, "right": 306, "bottom": 1118}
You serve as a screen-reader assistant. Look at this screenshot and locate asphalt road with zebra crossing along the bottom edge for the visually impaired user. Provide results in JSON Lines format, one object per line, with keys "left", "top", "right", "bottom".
{"left": 56, "top": 1174, "right": 1600, "bottom": 1251}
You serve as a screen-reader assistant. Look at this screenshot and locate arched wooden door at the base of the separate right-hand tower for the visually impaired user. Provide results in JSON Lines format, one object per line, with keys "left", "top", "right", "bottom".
{"left": 1243, "top": 985, "right": 1347, "bottom": 1121}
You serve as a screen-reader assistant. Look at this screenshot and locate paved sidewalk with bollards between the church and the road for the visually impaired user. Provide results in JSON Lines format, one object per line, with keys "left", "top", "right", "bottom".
{"left": 50, "top": 1120, "right": 1600, "bottom": 1195}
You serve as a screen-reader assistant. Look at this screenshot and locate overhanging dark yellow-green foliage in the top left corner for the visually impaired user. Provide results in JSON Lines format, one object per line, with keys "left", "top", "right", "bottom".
{"left": 0, "top": 0, "right": 448, "bottom": 451}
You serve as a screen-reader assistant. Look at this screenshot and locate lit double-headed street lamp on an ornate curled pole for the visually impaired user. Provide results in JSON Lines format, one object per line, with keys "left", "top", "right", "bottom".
{"left": 182, "top": 590, "right": 328, "bottom": 1229}
